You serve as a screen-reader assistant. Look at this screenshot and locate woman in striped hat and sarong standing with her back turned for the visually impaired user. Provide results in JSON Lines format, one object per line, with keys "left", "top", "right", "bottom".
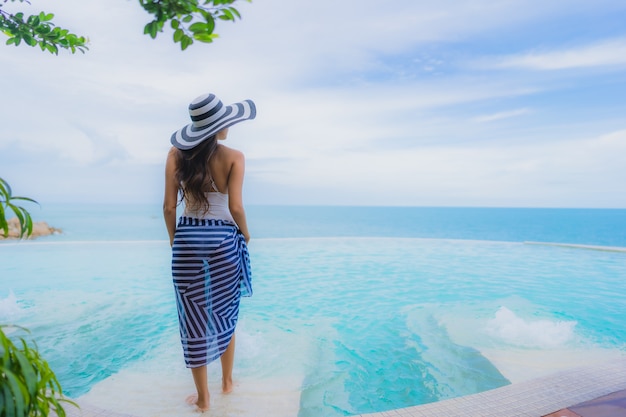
{"left": 163, "top": 94, "right": 256, "bottom": 412}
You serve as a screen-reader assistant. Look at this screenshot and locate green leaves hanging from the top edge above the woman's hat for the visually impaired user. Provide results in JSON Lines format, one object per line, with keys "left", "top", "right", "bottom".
{"left": 139, "top": 0, "right": 252, "bottom": 50}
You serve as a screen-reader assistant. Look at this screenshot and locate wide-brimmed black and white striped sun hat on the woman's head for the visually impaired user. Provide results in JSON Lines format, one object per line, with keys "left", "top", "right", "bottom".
{"left": 170, "top": 93, "right": 256, "bottom": 150}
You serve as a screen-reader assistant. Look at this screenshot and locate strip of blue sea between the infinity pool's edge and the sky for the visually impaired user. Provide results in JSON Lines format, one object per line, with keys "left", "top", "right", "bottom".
{"left": 15, "top": 203, "right": 626, "bottom": 247}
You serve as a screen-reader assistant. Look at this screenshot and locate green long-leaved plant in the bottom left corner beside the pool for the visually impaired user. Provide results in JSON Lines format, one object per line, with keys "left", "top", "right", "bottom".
{"left": 0, "top": 326, "right": 78, "bottom": 417}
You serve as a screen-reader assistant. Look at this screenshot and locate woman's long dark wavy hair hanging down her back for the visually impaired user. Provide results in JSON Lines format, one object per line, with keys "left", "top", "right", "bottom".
{"left": 176, "top": 135, "right": 217, "bottom": 212}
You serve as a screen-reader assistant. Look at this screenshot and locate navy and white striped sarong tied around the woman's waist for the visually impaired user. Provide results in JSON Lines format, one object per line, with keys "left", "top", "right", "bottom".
{"left": 172, "top": 216, "right": 252, "bottom": 368}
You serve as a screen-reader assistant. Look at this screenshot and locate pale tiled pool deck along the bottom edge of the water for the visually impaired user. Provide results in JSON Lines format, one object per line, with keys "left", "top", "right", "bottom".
{"left": 66, "top": 356, "right": 626, "bottom": 417}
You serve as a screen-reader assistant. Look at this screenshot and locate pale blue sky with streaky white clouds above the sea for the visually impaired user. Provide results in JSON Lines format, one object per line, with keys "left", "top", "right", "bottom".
{"left": 0, "top": 0, "right": 626, "bottom": 208}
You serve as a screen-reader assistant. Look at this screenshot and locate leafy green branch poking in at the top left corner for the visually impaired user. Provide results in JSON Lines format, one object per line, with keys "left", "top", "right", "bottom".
{"left": 0, "top": 0, "right": 88, "bottom": 55}
